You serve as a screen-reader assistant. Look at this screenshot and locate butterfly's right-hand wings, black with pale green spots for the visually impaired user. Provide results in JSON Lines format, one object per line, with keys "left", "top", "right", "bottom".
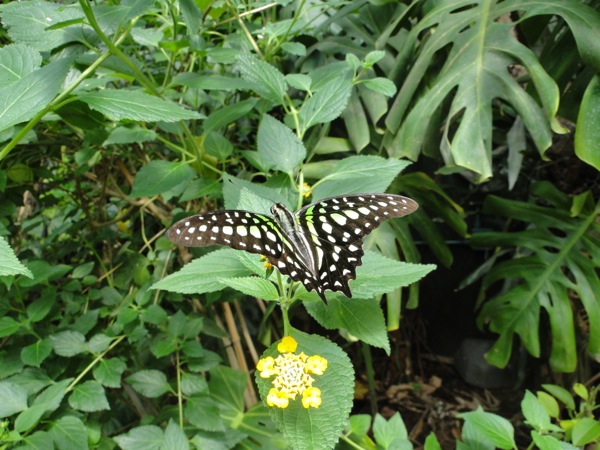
{"left": 297, "top": 194, "right": 419, "bottom": 297}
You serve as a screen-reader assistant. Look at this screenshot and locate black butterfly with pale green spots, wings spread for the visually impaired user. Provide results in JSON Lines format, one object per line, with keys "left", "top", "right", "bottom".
{"left": 167, "top": 194, "right": 419, "bottom": 300}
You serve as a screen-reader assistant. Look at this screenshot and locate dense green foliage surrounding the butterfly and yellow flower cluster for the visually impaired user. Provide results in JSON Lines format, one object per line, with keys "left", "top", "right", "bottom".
{"left": 0, "top": 0, "right": 600, "bottom": 450}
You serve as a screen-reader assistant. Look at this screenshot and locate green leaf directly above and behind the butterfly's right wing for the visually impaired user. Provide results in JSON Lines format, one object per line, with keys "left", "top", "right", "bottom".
{"left": 312, "top": 156, "right": 410, "bottom": 201}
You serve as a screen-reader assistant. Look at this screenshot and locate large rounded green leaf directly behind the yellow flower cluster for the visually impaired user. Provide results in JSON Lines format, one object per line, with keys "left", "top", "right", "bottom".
{"left": 256, "top": 330, "right": 354, "bottom": 450}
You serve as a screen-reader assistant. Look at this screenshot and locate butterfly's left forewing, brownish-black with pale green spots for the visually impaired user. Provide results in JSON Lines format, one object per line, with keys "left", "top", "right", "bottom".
{"left": 167, "top": 210, "right": 284, "bottom": 258}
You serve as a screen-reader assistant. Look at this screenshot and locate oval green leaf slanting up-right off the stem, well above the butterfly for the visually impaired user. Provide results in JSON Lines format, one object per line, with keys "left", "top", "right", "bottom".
{"left": 298, "top": 77, "right": 352, "bottom": 134}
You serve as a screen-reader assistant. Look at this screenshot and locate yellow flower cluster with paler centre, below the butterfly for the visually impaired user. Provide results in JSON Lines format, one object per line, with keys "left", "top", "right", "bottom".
{"left": 256, "top": 336, "right": 327, "bottom": 408}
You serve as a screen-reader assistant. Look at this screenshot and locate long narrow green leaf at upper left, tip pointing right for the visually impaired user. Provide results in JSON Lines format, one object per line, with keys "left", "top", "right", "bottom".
{"left": 79, "top": 89, "right": 203, "bottom": 122}
